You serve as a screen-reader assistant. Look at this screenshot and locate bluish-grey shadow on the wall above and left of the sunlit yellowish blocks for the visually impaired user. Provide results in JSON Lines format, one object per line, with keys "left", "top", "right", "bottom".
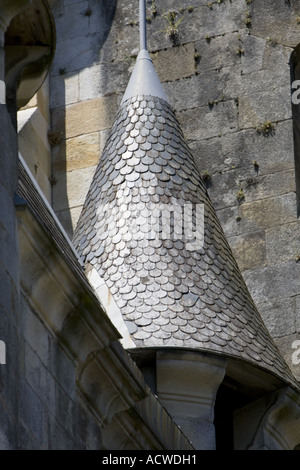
{"left": 49, "top": 0, "right": 117, "bottom": 238}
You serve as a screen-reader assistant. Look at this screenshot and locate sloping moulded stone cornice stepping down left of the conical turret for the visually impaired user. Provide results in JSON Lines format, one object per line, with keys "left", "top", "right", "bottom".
{"left": 17, "top": 186, "right": 192, "bottom": 449}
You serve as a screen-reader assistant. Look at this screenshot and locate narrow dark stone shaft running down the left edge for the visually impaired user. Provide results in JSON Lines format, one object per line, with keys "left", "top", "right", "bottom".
{"left": 0, "top": 102, "right": 20, "bottom": 449}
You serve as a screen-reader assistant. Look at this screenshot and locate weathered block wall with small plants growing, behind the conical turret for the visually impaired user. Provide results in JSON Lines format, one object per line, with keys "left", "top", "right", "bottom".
{"left": 50, "top": 0, "right": 300, "bottom": 378}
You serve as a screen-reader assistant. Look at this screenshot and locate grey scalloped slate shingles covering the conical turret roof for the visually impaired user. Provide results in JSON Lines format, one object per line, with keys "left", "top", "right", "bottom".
{"left": 73, "top": 96, "right": 294, "bottom": 382}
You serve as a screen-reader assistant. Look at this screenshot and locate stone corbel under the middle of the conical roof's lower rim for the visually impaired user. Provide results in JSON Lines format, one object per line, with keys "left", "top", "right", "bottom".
{"left": 156, "top": 351, "right": 226, "bottom": 450}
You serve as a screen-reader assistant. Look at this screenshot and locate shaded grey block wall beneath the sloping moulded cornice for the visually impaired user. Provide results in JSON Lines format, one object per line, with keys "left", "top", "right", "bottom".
{"left": 18, "top": 295, "right": 102, "bottom": 450}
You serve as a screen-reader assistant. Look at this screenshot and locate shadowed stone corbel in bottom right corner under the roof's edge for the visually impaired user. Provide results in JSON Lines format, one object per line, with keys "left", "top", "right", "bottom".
{"left": 234, "top": 387, "right": 300, "bottom": 450}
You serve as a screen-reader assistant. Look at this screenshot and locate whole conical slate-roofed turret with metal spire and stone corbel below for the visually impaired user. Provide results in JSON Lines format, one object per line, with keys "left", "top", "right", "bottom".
{"left": 73, "top": 0, "right": 298, "bottom": 449}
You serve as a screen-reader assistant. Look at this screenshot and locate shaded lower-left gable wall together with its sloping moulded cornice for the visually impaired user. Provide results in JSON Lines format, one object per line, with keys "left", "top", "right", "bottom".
{"left": 15, "top": 182, "right": 193, "bottom": 450}
